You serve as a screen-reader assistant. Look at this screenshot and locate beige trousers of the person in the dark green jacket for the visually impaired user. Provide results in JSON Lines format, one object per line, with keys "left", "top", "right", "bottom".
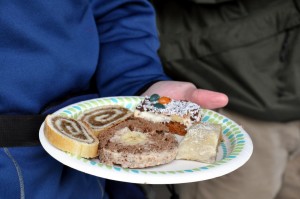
{"left": 145, "top": 110, "right": 300, "bottom": 199}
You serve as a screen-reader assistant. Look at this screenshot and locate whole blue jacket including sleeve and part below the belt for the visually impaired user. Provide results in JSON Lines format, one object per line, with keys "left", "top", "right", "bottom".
{"left": 0, "top": 0, "right": 167, "bottom": 199}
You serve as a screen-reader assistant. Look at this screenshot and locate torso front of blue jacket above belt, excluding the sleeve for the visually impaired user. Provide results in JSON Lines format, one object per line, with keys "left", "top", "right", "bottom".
{"left": 0, "top": 0, "right": 99, "bottom": 114}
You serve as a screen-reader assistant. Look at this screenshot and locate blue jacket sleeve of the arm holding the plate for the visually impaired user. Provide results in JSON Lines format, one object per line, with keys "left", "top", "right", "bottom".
{"left": 93, "top": 0, "right": 168, "bottom": 96}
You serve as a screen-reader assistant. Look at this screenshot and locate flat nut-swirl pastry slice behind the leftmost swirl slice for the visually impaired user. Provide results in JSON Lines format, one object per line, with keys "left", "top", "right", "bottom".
{"left": 79, "top": 105, "right": 133, "bottom": 136}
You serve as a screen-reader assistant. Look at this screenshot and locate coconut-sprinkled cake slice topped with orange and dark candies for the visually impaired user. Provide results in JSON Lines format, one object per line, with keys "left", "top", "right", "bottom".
{"left": 134, "top": 94, "right": 201, "bottom": 135}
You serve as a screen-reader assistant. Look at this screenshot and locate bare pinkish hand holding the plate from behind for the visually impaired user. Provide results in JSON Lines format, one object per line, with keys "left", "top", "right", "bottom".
{"left": 142, "top": 81, "right": 228, "bottom": 109}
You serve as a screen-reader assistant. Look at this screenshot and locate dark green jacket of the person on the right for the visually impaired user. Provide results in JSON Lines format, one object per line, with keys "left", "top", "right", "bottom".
{"left": 153, "top": 0, "right": 300, "bottom": 121}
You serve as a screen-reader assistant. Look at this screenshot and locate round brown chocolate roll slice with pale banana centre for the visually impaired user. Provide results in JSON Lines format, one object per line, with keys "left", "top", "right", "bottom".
{"left": 99, "top": 118, "right": 178, "bottom": 168}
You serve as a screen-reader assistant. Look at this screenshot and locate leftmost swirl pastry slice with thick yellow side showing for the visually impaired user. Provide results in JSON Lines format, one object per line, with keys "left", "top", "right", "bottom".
{"left": 44, "top": 115, "right": 99, "bottom": 158}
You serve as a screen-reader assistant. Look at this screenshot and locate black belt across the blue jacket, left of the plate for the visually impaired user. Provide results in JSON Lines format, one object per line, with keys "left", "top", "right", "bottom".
{"left": 0, "top": 115, "right": 46, "bottom": 147}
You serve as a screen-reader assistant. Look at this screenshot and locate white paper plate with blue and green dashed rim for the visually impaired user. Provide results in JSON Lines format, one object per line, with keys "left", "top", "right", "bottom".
{"left": 39, "top": 97, "right": 253, "bottom": 184}
